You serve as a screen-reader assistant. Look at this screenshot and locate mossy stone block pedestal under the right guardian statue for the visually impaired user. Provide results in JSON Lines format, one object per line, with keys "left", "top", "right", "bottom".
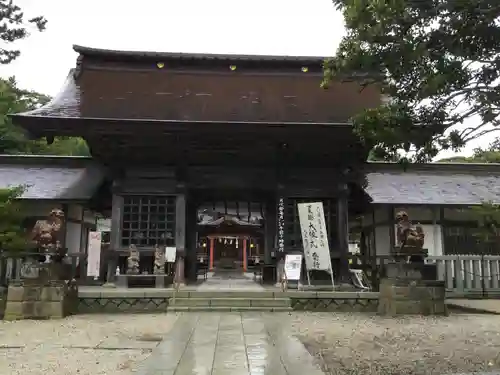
{"left": 378, "top": 263, "right": 448, "bottom": 316}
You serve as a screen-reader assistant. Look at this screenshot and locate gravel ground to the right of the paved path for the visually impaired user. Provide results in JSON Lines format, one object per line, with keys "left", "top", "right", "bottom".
{"left": 288, "top": 313, "right": 500, "bottom": 375}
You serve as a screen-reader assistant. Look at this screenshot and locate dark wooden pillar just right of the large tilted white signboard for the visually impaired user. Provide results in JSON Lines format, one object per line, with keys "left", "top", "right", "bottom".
{"left": 337, "top": 184, "right": 350, "bottom": 283}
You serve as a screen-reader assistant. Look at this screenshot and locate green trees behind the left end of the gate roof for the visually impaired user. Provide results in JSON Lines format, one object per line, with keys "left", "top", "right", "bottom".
{"left": 0, "top": 78, "right": 89, "bottom": 156}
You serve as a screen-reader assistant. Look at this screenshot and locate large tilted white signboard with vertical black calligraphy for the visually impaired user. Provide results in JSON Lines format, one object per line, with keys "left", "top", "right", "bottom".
{"left": 298, "top": 202, "right": 332, "bottom": 273}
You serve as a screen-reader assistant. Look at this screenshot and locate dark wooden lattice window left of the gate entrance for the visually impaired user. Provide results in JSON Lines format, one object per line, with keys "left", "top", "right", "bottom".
{"left": 121, "top": 196, "right": 175, "bottom": 247}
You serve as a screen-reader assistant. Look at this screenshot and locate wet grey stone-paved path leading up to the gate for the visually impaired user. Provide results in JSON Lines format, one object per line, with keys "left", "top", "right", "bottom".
{"left": 138, "top": 313, "right": 323, "bottom": 375}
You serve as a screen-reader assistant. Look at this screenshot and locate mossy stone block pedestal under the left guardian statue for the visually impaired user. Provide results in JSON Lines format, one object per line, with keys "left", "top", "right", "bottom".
{"left": 3, "top": 282, "right": 78, "bottom": 320}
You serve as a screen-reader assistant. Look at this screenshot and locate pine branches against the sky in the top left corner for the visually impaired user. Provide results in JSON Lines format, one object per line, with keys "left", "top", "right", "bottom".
{"left": 0, "top": 0, "right": 47, "bottom": 64}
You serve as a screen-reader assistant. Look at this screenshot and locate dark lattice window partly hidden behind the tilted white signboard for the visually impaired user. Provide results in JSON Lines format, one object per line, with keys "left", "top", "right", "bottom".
{"left": 285, "top": 198, "right": 337, "bottom": 249}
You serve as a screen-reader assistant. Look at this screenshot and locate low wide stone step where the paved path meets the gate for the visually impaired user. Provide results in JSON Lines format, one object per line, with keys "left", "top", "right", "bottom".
{"left": 169, "top": 297, "right": 290, "bottom": 308}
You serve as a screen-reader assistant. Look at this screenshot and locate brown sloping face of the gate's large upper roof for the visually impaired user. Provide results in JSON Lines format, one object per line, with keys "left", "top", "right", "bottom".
{"left": 78, "top": 67, "right": 380, "bottom": 122}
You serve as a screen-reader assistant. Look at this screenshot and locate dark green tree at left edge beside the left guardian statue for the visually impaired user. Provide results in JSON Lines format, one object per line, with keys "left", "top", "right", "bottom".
{"left": 0, "top": 187, "right": 28, "bottom": 251}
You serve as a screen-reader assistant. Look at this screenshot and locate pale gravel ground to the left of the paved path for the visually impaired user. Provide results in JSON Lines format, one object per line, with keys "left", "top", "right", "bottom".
{"left": 0, "top": 314, "right": 177, "bottom": 375}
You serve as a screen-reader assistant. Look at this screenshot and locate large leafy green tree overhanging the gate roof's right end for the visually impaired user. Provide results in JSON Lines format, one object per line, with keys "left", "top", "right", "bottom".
{"left": 323, "top": 0, "right": 500, "bottom": 161}
